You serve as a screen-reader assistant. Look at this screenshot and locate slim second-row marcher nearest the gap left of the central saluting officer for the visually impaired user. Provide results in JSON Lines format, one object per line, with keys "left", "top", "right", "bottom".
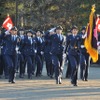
{"left": 36, "top": 30, "right": 44, "bottom": 77}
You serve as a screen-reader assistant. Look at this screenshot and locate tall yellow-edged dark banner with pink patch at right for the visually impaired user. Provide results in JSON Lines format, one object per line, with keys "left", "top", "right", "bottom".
{"left": 84, "top": 5, "right": 98, "bottom": 62}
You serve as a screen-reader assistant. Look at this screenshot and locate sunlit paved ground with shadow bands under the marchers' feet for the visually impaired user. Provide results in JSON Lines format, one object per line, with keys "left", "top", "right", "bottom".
{"left": 0, "top": 64, "right": 100, "bottom": 100}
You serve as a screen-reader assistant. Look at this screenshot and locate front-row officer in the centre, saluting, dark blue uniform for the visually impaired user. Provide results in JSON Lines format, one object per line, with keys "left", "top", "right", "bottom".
{"left": 50, "top": 26, "right": 64, "bottom": 84}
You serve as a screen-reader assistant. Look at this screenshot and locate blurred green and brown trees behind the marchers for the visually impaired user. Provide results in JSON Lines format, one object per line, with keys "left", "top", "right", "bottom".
{"left": 0, "top": 0, "right": 100, "bottom": 30}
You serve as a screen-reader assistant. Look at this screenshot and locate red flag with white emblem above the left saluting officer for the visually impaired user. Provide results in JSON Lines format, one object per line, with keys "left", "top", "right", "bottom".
{"left": 2, "top": 16, "right": 13, "bottom": 30}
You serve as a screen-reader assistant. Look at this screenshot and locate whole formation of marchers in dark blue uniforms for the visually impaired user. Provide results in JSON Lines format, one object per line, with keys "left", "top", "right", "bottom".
{"left": 0, "top": 26, "right": 89, "bottom": 86}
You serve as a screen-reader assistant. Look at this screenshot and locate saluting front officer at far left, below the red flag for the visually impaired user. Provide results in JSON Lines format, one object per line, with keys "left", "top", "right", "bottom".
{"left": 1, "top": 27, "right": 18, "bottom": 83}
